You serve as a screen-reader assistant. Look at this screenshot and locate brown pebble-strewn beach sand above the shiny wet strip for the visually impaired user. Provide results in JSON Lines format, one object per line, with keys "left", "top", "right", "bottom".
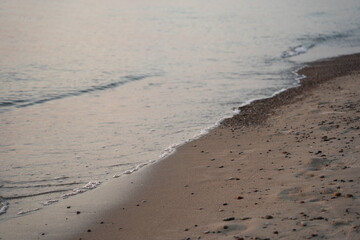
{"left": 74, "top": 55, "right": 360, "bottom": 240}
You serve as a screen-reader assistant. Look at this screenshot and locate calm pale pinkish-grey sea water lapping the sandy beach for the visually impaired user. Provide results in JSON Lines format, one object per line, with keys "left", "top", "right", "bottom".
{"left": 0, "top": 0, "right": 360, "bottom": 221}
